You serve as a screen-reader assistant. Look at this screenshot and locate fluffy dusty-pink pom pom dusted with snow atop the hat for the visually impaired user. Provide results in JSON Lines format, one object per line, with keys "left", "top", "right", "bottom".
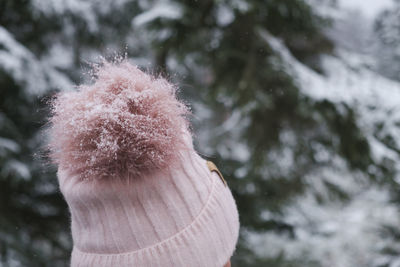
{"left": 49, "top": 60, "right": 191, "bottom": 179}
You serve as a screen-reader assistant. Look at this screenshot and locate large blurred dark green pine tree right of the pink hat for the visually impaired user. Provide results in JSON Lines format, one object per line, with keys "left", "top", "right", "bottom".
{"left": 132, "top": 0, "right": 386, "bottom": 266}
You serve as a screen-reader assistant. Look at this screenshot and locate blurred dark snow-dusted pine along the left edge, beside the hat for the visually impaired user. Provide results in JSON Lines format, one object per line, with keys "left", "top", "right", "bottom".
{"left": 0, "top": 1, "right": 69, "bottom": 266}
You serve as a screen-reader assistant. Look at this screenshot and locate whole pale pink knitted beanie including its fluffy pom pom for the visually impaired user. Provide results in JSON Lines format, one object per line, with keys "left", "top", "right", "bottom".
{"left": 49, "top": 60, "right": 239, "bottom": 267}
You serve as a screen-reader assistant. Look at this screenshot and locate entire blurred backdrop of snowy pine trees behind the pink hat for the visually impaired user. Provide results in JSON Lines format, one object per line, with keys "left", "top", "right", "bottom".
{"left": 0, "top": 0, "right": 400, "bottom": 267}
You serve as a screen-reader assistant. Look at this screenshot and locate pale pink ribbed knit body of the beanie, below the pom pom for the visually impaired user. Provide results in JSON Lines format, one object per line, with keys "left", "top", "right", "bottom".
{"left": 58, "top": 138, "right": 239, "bottom": 267}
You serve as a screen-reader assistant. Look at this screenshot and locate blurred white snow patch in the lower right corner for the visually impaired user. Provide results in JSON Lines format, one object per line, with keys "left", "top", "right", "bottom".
{"left": 252, "top": 189, "right": 400, "bottom": 267}
